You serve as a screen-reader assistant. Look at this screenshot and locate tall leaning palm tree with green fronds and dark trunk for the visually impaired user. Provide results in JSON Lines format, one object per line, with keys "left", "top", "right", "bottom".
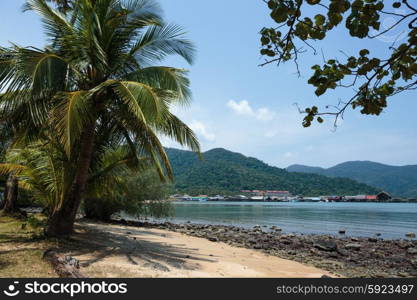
{"left": 0, "top": 0, "right": 199, "bottom": 236}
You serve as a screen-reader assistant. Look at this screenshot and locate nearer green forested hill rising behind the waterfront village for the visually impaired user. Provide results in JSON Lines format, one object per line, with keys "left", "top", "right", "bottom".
{"left": 167, "top": 148, "right": 378, "bottom": 196}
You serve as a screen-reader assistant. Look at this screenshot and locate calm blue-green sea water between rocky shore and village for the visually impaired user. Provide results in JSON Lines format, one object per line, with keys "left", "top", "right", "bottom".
{"left": 157, "top": 202, "right": 417, "bottom": 239}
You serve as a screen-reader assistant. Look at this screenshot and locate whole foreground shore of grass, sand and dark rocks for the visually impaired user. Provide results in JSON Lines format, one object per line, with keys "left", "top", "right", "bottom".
{"left": 0, "top": 213, "right": 417, "bottom": 278}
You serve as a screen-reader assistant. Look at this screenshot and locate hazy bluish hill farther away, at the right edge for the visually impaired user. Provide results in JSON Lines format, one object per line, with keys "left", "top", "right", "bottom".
{"left": 287, "top": 161, "right": 417, "bottom": 198}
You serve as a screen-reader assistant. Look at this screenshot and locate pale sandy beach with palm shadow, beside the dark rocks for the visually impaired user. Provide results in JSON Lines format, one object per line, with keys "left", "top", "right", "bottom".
{"left": 71, "top": 221, "right": 334, "bottom": 278}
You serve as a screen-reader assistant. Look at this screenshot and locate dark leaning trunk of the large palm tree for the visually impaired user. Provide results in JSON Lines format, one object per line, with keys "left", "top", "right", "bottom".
{"left": 45, "top": 121, "right": 95, "bottom": 237}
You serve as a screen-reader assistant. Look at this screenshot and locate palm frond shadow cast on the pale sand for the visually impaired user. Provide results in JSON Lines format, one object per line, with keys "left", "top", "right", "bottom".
{"left": 55, "top": 220, "right": 215, "bottom": 272}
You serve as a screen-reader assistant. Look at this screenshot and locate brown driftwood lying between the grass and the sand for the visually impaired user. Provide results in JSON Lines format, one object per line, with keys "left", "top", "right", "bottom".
{"left": 43, "top": 249, "right": 85, "bottom": 278}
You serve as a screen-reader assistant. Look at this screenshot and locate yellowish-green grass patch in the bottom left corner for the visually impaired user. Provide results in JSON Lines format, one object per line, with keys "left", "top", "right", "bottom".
{"left": 0, "top": 215, "right": 56, "bottom": 278}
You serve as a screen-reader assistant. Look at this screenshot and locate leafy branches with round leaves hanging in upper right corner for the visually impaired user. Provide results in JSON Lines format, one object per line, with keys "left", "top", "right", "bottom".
{"left": 261, "top": 0, "right": 417, "bottom": 127}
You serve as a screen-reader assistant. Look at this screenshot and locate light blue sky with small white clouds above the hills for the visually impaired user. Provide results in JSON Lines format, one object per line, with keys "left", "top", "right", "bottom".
{"left": 0, "top": 0, "right": 417, "bottom": 167}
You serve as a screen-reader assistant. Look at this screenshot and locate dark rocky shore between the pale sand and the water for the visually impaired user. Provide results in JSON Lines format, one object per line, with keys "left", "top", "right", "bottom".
{"left": 108, "top": 219, "right": 417, "bottom": 278}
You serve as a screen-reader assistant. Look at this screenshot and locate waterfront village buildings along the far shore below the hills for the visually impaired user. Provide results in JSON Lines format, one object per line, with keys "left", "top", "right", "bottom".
{"left": 170, "top": 190, "right": 417, "bottom": 203}
